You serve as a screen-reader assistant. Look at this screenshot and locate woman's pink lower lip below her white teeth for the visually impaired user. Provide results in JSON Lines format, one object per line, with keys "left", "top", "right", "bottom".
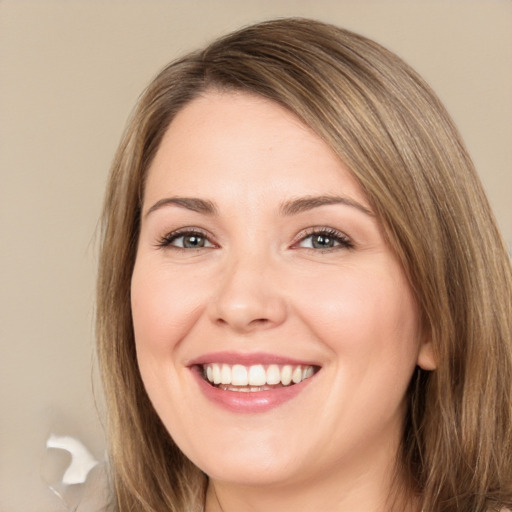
{"left": 192, "top": 367, "right": 314, "bottom": 413}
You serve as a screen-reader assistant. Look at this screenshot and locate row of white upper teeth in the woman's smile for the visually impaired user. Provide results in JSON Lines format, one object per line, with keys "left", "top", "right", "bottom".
{"left": 203, "top": 363, "right": 314, "bottom": 386}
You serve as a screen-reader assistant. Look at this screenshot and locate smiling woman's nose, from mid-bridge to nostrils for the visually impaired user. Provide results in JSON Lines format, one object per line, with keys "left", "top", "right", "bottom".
{"left": 210, "top": 255, "right": 287, "bottom": 334}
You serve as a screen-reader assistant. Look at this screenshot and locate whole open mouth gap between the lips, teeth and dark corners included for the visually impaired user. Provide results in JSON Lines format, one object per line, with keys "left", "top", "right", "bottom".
{"left": 200, "top": 363, "right": 319, "bottom": 392}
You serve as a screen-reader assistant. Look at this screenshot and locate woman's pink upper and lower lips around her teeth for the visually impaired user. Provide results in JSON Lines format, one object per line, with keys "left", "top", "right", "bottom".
{"left": 188, "top": 352, "right": 317, "bottom": 413}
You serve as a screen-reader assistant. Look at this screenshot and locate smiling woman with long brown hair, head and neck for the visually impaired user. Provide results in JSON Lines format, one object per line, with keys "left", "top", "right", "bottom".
{"left": 98, "top": 19, "right": 512, "bottom": 512}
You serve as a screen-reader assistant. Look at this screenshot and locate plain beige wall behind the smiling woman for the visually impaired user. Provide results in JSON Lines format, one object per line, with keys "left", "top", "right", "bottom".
{"left": 0, "top": 0, "right": 512, "bottom": 512}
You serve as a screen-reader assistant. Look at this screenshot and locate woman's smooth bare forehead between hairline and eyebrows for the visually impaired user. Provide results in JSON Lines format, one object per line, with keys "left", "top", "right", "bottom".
{"left": 145, "top": 91, "right": 367, "bottom": 210}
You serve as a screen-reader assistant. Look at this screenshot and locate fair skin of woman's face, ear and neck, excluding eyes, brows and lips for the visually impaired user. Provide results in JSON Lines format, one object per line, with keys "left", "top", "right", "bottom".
{"left": 131, "top": 91, "right": 433, "bottom": 512}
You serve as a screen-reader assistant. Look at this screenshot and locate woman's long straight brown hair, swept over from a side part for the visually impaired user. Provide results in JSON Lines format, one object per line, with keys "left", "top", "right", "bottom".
{"left": 97, "top": 19, "right": 512, "bottom": 512}
